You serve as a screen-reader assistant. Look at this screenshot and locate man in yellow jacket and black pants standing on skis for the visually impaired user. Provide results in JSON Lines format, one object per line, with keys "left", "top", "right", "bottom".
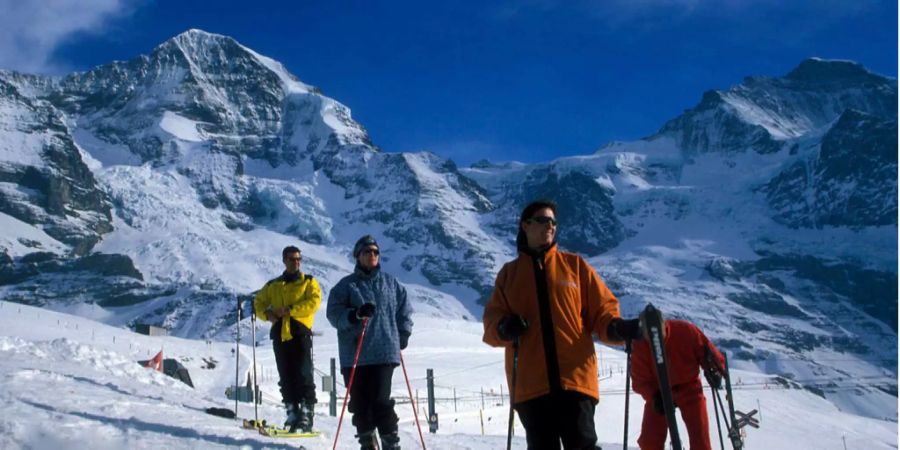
{"left": 253, "top": 246, "right": 322, "bottom": 431}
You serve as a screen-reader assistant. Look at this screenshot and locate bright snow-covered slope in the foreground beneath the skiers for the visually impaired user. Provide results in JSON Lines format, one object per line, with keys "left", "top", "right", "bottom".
{"left": 0, "top": 302, "right": 897, "bottom": 450}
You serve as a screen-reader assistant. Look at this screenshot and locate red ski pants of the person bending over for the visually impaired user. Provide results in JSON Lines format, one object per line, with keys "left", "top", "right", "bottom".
{"left": 638, "top": 383, "right": 712, "bottom": 450}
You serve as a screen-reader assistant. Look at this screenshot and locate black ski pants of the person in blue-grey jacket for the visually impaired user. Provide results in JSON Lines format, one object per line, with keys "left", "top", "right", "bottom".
{"left": 341, "top": 364, "right": 399, "bottom": 436}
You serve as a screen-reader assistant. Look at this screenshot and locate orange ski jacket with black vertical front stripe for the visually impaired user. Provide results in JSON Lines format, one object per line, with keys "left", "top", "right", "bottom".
{"left": 483, "top": 244, "right": 619, "bottom": 403}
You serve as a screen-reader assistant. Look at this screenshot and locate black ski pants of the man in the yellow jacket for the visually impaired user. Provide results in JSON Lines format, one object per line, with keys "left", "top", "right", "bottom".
{"left": 270, "top": 320, "right": 316, "bottom": 404}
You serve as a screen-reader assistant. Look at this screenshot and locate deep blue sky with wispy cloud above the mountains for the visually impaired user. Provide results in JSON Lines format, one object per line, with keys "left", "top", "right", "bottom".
{"left": 0, "top": 0, "right": 898, "bottom": 165}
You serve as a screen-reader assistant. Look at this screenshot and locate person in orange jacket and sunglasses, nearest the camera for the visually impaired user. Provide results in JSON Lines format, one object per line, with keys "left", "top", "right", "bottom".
{"left": 483, "top": 200, "right": 641, "bottom": 450}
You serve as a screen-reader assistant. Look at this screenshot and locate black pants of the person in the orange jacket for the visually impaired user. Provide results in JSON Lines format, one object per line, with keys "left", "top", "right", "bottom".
{"left": 515, "top": 391, "right": 597, "bottom": 450}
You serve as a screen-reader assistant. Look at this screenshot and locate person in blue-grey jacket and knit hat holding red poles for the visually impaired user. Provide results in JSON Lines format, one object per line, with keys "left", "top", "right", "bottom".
{"left": 326, "top": 235, "right": 413, "bottom": 450}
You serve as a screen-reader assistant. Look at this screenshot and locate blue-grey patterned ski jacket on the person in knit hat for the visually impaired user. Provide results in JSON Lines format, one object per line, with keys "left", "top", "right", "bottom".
{"left": 326, "top": 267, "right": 413, "bottom": 368}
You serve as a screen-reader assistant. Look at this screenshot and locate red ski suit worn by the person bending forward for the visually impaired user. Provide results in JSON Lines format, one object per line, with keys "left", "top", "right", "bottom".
{"left": 631, "top": 314, "right": 725, "bottom": 450}
